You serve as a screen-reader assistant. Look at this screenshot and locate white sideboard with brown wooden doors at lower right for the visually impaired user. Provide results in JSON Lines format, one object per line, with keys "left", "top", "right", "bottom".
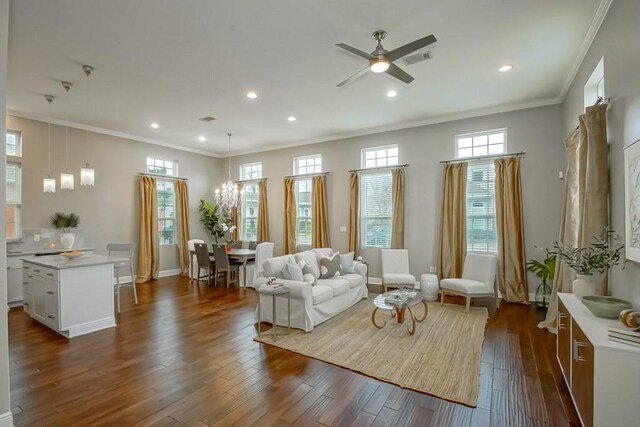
{"left": 556, "top": 293, "right": 640, "bottom": 427}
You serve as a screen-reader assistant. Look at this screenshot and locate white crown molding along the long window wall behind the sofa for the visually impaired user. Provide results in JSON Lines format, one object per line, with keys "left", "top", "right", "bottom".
{"left": 230, "top": 97, "right": 562, "bottom": 157}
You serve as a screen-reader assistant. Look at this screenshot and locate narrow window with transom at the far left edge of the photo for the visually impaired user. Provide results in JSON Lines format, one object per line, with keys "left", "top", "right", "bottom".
{"left": 5, "top": 131, "right": 22, "bottom": 240}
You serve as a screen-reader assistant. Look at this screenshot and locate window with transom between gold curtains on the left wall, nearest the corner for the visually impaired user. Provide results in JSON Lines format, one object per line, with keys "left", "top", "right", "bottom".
{"left": 147, "top": 157, "right": 178, "bottom": 245}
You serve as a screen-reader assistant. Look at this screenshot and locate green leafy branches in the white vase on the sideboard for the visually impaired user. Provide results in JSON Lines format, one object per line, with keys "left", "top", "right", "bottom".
{"left": 553, "top": 228, "right": 624, "bottom": 275}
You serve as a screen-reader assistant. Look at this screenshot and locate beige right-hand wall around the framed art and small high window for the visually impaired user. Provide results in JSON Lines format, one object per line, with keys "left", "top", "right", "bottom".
{"left": 562, "top": 0, "right": 640, "bottom": 309}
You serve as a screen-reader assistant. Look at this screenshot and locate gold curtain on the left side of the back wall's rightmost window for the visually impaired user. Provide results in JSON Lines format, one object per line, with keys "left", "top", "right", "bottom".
{"left": 438, "top": 162, "right": 467, "bottom": 279}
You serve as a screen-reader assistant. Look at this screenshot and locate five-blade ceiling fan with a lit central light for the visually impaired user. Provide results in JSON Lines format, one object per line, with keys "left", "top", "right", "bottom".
{"left": 336, "top": 30, "right": 437, "bottom": 87}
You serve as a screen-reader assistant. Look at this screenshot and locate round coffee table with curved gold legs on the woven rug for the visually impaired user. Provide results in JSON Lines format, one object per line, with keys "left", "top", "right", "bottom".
{"left": 371, "top": 289, "right": 429, "bottom": 335}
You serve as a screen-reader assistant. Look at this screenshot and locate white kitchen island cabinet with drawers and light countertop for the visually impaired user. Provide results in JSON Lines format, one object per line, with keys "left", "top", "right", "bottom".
{"left": 22, "top": 254, "right": 124, "bottom": 338}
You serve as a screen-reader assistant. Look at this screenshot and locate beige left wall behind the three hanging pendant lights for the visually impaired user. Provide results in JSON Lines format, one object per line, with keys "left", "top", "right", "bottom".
{"left": 7, "top": 114, "right": 226, "bottom": 271}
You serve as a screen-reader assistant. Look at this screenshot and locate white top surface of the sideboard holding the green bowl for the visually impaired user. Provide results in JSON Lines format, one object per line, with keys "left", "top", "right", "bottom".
{"left": 558, "top": 293, "right": 640, "bottom": 354}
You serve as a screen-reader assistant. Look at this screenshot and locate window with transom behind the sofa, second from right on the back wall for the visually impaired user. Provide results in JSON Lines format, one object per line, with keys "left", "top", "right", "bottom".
{"left": 360, "top": 145, "right": 398, "bottom": 248}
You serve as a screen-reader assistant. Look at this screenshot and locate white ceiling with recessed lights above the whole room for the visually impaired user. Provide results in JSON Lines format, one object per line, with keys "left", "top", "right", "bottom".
{"left": 7, "top": 0, "right": 609, "bottom": 155}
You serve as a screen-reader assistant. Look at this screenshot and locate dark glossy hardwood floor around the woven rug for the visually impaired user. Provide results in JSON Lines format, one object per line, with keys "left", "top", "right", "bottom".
{"left": 9, "top": 277, "right": 579, "bottom": 426}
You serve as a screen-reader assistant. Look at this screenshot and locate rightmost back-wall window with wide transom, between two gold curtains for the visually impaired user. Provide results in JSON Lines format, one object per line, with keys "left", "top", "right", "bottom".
{"left": 456, "top": 129, "right": 507, "bottom": 253}
